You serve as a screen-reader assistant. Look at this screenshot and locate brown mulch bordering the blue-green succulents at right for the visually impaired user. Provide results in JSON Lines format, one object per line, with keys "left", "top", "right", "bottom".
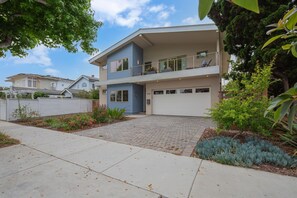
{"left": 191, "top": 128, "right": 297, "bottom": 177}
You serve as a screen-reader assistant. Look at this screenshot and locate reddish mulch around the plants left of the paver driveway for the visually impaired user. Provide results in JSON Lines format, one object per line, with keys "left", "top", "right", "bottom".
{"left": 13, "top": 114, "right": 135, "bottom": 133}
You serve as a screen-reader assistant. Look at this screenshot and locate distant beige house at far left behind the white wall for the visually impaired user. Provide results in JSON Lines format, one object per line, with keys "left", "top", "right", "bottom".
{"left": 6, "top": 73, "right": 74, "bottom": 95}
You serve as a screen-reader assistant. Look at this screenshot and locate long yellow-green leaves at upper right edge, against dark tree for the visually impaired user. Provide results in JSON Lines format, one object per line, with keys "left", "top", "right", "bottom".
{"left": 262, "top": 6, "right": 297, "bottom": 58}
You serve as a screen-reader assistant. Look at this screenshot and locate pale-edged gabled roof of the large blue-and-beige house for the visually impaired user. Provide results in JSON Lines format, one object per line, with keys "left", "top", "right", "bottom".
{"left": 89, "top": 24, "right": 218, "bottom": 65}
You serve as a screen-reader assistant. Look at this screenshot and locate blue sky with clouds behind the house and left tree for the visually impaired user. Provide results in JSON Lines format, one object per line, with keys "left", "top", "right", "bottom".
{"left": 0, "top": 0, "right": 211, "bottom": 86}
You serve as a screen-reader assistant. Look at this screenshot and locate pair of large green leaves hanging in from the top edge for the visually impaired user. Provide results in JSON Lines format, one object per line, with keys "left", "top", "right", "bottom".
{"left": 198, "top": 0, "right": 260, "bottom": 20}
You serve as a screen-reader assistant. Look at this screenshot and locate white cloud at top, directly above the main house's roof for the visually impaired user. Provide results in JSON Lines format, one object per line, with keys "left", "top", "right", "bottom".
{"left": 92, "top": 0, "right": 175, "bottom": 27}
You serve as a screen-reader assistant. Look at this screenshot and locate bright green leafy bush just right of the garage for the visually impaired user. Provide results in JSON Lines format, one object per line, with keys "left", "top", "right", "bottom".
{"left": 210, "top": 66, "right": 272, "bottom": 135}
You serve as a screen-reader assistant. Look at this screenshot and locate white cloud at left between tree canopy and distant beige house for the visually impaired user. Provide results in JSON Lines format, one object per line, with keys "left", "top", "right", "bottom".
{"left": 12, "top": 45, "right": 52, "bottom": 66}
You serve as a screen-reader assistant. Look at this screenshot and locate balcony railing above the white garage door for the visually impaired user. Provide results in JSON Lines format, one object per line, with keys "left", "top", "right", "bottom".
{"left": 130, "top": 52, "right": 219, "bottom": 76}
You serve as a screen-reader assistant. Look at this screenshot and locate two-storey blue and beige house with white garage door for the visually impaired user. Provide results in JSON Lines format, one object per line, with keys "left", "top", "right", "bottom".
{"left": 89, "top": 24, "right": 229, "bottom": 116}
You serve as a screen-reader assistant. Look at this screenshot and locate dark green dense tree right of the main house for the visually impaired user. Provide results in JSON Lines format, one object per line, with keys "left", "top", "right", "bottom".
{"left": 208, "top": 0, "right": 297, "bottom": 95}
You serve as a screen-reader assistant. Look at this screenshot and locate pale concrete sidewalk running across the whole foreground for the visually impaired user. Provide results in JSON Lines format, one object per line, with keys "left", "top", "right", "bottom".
{"left": 0, "top": 121, "right": 297, "bottom": 198}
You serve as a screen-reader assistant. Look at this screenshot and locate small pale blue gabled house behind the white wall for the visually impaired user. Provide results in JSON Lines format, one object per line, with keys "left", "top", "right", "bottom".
{"left": 61, "top": 75, "right": 99, "bottom": 98}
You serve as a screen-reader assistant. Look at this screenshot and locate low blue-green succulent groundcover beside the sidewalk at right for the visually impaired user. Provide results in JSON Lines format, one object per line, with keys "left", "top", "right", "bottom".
{"left": 195, "top": 137, "right": 297, "bottom": 168}
